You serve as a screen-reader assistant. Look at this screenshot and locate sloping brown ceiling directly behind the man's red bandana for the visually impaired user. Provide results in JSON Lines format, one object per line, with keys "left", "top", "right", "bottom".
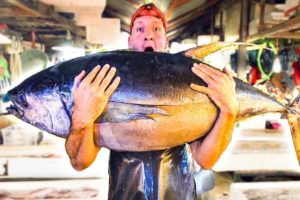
{"left": 103, "top": 0, "right": 221, "bottom": 40}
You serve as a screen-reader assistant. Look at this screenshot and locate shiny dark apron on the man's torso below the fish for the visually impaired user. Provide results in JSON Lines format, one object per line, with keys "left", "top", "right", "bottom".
{"left": 108, "top": 145, "right": 196, "bottom": 200}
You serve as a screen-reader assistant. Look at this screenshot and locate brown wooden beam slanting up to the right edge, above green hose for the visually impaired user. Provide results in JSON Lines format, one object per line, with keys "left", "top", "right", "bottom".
{"left": 247, "top": 14, "right": 300, "bottom": 42}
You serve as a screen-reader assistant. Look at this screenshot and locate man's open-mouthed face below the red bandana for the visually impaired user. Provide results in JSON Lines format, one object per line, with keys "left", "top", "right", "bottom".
{"left": 128, "top": 16, "right": 168, "bottom": 52}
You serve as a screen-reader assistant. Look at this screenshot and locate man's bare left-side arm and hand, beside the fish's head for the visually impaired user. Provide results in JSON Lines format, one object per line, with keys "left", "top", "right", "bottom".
{"left": 65, "top": 65, "right": 120, "bottom": 170}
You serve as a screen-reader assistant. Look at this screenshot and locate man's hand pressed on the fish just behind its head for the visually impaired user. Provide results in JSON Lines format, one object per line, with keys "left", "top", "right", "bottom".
{"left": 72, "top": 64, "right": 120, "bottom": 129}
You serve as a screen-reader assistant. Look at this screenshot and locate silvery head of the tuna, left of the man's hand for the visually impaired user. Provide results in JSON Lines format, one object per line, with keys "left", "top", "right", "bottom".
{"left": 6, "top": 75, "right": 72, "bottom": 137}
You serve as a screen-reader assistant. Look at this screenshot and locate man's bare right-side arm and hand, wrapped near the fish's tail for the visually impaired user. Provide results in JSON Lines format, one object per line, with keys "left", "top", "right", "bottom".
{"left": 190, "top": 64, "right": 239, "bottom": 169}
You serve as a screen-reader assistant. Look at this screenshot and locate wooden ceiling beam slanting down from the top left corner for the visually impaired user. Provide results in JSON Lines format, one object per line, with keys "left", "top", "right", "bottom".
{"left": 7, "top": 0, "right": 86, "bottom": 37}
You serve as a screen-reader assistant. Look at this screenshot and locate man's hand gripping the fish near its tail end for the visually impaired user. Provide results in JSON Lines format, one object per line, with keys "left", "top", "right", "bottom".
{"left": 190, "top": 63, "right": 239, "bottom": 115}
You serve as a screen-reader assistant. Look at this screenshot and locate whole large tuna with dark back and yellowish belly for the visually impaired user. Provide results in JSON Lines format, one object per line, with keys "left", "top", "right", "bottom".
{"left": 7, "top": 44, "right": 300, "bottom": 163}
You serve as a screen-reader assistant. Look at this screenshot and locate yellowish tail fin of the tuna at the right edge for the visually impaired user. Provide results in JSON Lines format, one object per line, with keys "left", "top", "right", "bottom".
{"left": 287, "top": 95, "right": 300, "bottom": 164}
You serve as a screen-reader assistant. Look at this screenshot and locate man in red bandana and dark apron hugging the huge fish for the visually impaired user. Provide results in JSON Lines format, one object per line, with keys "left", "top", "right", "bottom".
{"left": 66, "top": 4, "right": 239, "bottom": 199}
